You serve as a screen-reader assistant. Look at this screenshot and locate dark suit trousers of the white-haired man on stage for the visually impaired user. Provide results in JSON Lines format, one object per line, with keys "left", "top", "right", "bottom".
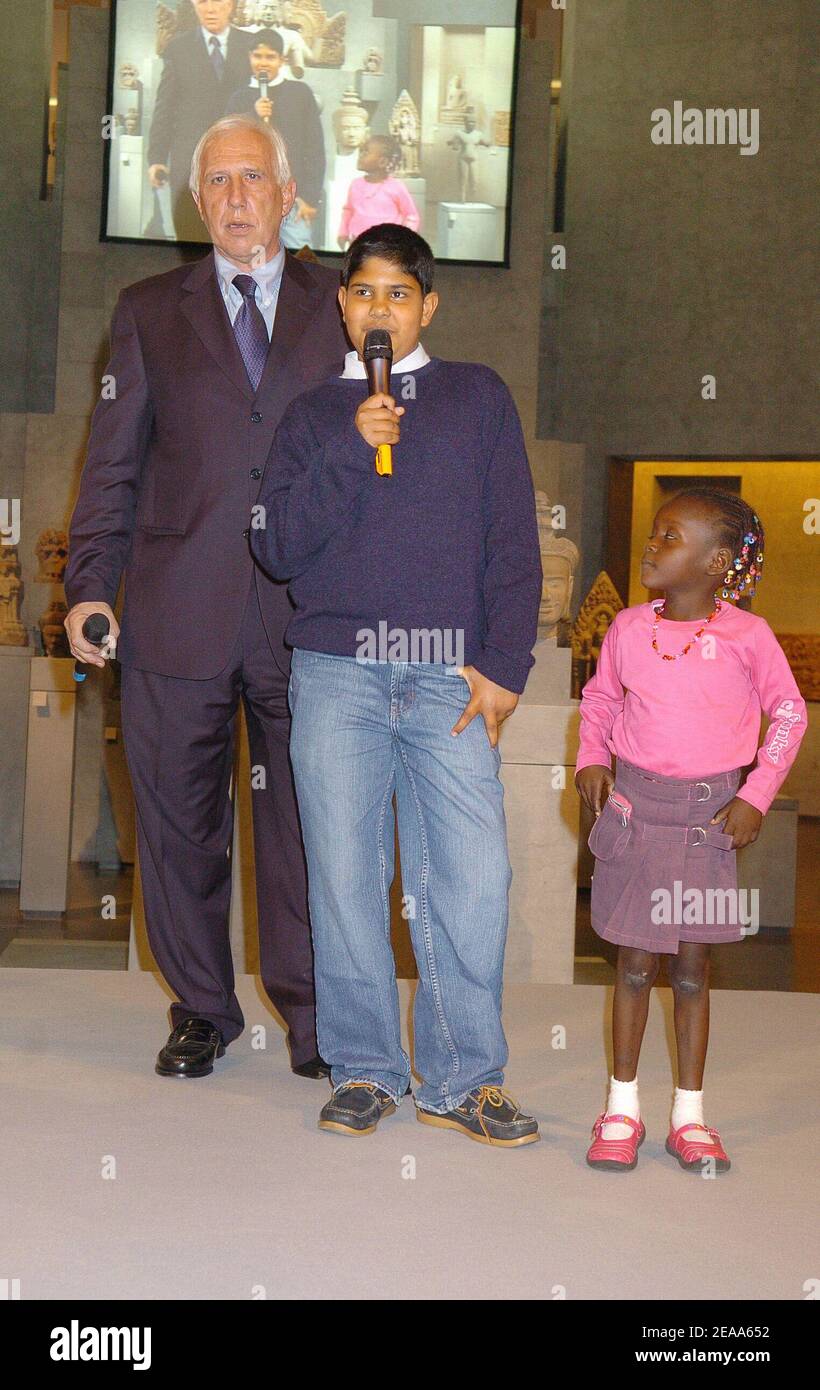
{"left": 122, "top": 577, "right": 318, "bottom": 1066}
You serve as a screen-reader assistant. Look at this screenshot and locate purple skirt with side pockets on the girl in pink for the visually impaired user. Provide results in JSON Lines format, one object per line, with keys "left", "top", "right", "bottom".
{"left": 589, "top": 759, "right": 749, "bottom": 955}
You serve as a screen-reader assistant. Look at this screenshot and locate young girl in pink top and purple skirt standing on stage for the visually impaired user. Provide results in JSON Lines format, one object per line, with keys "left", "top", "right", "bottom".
{"left": 575, "top": 487, "right": 806, "bottom": 1172}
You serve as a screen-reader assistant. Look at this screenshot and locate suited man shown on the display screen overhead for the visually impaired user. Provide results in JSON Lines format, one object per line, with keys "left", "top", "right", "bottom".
{"left": 147, "top": 0, "right": 253, "bottom": 242}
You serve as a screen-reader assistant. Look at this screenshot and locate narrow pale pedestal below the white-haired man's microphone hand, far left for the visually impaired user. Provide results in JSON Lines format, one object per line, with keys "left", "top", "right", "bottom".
{"left": 19, "top": 656, "right": 76, "bottom": 915}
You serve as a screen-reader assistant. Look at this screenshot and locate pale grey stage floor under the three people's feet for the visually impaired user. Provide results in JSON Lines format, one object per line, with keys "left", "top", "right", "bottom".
{"left": 0, "top": 969, "right": 820, "bottom": 1300}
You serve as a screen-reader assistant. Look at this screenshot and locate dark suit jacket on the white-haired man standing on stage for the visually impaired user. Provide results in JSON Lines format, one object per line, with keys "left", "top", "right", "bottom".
{"left": 65, "top": 253, "right": 349, "bottom": 680}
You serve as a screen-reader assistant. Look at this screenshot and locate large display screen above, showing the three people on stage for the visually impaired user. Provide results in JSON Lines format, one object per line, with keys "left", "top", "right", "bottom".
{"left": 103, "top": 0, "right": 520, "bottom": 264}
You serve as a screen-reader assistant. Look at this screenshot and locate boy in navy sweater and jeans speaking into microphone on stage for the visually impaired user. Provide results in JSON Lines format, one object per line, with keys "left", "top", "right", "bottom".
{"left": 252, "top": 224, "right": 541, "bottom": 1147}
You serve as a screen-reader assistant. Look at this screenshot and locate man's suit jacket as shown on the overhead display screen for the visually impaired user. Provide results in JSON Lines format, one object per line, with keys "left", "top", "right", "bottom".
{"left": 147, "top": 25, "right": 253, "bottom": 205}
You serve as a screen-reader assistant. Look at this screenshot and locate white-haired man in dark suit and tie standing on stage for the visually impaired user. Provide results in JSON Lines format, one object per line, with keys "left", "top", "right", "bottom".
{"left": 65, "top": 117, "right": 347, "bottom": 1076}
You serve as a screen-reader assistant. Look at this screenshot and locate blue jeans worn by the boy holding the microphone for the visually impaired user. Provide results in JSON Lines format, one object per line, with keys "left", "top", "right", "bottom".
{"left": 289, "top": 649, "right": 511, "bottom": 1112}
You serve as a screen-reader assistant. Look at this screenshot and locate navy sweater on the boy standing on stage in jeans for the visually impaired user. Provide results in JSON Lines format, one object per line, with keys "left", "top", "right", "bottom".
{"left": 250, "top": 357, "right": 541, "bottom": 694}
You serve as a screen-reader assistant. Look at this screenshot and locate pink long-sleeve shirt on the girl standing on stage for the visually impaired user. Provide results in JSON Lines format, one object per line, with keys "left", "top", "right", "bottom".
{"left": 577, "top": 600, "right": 806, "bottom": 815}
